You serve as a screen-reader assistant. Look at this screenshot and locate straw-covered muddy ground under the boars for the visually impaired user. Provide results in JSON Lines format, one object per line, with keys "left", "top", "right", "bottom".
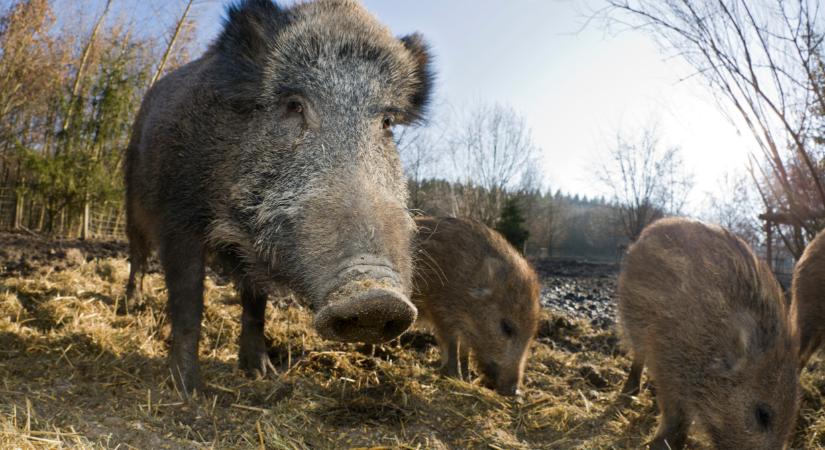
{"left": 0, "top": 234, "right": 825, "bottom": 449}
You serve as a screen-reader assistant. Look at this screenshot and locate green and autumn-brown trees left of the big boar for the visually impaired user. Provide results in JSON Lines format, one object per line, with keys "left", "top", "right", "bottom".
{"left": 0, "top": 0, "right": 156, "bottom": 234}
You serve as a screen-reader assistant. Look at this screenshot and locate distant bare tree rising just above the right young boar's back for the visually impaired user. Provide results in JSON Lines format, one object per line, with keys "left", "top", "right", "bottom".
{"left": 596, "top": 124, "right": 693, "bottom": 242}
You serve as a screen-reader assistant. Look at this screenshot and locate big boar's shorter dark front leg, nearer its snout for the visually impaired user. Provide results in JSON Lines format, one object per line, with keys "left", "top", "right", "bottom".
{"left": 238, "top": 282, "right": 275, "bottom": 377}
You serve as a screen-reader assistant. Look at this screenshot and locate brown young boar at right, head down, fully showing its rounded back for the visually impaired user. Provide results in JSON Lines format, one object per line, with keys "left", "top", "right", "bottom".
{"left": 618, "top": 219, "right": 799, "bottom": 449}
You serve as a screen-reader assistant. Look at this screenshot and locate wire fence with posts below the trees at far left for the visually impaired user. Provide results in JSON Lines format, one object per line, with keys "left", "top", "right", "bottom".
{"left": 0, "top": 188, "right": 126, "bottom": 240}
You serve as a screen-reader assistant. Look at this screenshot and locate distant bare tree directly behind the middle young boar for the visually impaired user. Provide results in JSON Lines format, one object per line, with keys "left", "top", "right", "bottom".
{"left": 451, "top": 104, "right": 539, "bottom": 225}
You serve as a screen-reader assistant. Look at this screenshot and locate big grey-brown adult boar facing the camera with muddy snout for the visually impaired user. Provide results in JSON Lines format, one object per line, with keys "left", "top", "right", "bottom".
{"left": 126, "top": 0, "right": 431, "bottom": 392}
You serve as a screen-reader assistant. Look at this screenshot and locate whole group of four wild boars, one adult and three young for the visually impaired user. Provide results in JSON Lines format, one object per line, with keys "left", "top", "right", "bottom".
{"left": 114, "top": 0, "right": 825, "bottom": 449}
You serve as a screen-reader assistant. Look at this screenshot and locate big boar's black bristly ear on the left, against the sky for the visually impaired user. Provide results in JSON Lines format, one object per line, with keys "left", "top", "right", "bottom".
{"left": 212, "top": 0, "right": 287, "bottom": 109}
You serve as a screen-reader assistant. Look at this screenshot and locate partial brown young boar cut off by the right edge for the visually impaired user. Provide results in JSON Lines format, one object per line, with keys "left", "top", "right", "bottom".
{"left": 791, "top": 231, "right": 825, "bottom": 368}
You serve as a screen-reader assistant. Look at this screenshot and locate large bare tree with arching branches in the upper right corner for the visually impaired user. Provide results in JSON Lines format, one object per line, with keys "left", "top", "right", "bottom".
{"left": 608, "top": 0, "right": 825, "bottom": 253}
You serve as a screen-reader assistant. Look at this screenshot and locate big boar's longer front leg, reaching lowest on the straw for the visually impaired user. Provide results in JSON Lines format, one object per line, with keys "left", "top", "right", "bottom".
{"left": 161, "top": 233, "right": 204, "bottom": 398}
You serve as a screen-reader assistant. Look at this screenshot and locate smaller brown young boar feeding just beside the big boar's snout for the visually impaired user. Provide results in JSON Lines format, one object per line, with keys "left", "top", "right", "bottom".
{"left": 413, "top": 217, "right": 539, "bottom": 395}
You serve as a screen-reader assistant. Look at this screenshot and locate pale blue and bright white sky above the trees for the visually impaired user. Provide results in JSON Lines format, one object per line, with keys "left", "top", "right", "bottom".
{"left": 82, "top": 0, "right": 754, "bottom": 206}
